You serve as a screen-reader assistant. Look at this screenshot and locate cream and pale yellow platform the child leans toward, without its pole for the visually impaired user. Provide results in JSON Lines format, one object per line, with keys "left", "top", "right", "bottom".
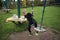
{"left": 6, "top": 14, "right": 27, "bottom": 23}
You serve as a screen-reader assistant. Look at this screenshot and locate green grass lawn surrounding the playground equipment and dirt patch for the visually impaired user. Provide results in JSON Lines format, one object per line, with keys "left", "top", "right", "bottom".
{"left": 0, "top": 6, "right": 60, "bottom": 40}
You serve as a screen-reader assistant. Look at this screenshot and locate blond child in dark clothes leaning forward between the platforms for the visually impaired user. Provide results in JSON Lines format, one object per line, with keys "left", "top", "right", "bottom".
{"left": 23, "top": 10, "right": 38, "bottom": 36}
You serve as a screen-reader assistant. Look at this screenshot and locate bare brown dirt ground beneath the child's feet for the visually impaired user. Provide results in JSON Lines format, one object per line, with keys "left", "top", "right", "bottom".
{"left": 8, "top": 27, "right": 60, "bottom": 40}
